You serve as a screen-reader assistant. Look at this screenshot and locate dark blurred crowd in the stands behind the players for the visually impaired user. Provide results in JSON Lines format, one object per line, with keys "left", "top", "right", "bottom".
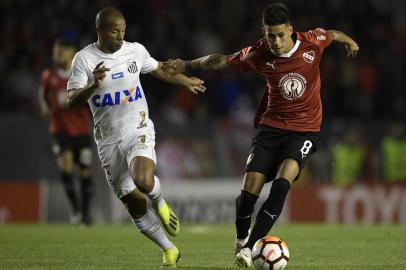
{"left": 0, "top": 0, "right": 406, "bottom": 184}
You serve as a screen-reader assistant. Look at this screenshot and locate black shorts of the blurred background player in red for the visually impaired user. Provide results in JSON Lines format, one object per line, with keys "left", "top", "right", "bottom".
{"left": 52, "top": 135, "right": 92, "bottom": 168}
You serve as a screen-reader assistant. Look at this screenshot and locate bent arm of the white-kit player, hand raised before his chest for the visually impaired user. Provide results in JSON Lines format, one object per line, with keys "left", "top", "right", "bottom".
{"left": 67, "top": 62, "right": 110, "bottom": 107}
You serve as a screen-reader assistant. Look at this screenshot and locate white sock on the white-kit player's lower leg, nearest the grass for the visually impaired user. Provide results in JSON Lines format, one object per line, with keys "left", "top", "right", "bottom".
{"left": 132, "top": 208, "right": 173, "bottom": 250}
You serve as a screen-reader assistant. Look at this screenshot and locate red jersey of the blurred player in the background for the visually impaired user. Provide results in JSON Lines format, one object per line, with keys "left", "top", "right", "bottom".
{"left": 40, "top": 68, "right": 91, "bottom": 136}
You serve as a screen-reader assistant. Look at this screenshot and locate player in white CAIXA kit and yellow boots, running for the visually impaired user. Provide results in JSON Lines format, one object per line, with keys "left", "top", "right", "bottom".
{"left": 67, "top": 7, "right": 205, "bottom": 267}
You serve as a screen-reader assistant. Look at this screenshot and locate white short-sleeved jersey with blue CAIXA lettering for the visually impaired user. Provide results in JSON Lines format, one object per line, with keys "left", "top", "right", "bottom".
{"left": 68, "top": 42, "right": 158, "bottom": 145}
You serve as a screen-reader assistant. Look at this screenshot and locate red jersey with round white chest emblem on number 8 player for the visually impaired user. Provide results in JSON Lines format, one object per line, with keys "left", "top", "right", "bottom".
{"left": 227, "top": 28, "right": 333, "bottom": 131}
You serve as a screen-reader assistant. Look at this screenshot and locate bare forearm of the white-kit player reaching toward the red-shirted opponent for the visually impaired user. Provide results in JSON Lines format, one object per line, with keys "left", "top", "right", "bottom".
{"left": 150, "top": 62, "right": 206, "bottom": 94}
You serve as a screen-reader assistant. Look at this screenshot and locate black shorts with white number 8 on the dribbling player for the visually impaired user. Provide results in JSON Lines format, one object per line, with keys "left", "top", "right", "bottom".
{"left": 245, "top": 125, "right": 321, "bottom": 182}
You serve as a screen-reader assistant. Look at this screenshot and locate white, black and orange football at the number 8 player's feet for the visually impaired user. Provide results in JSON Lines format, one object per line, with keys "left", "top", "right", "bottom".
{"left": 252, "top": 236, "right": 289, "bottom": 270}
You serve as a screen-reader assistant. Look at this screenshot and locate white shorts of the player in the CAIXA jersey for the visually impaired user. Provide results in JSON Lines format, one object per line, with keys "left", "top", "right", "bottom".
{"left": 97, "top": 128, "right": 156, "bottom": 198}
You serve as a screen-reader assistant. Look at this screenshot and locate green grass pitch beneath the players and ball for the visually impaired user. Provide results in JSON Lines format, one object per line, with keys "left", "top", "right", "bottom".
{"left": 0, "top": 224, "right": 406, "bottom": 270}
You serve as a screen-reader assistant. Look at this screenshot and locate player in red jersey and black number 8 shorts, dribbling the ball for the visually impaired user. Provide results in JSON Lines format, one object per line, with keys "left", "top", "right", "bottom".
{"left": 173, "top": 3, "right": 359, "bottom": 267}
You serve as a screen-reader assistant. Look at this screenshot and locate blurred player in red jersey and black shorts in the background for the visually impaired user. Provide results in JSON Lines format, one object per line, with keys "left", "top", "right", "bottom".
{"left": 39, "top": 39, "right": 93, "bottom": 225}
